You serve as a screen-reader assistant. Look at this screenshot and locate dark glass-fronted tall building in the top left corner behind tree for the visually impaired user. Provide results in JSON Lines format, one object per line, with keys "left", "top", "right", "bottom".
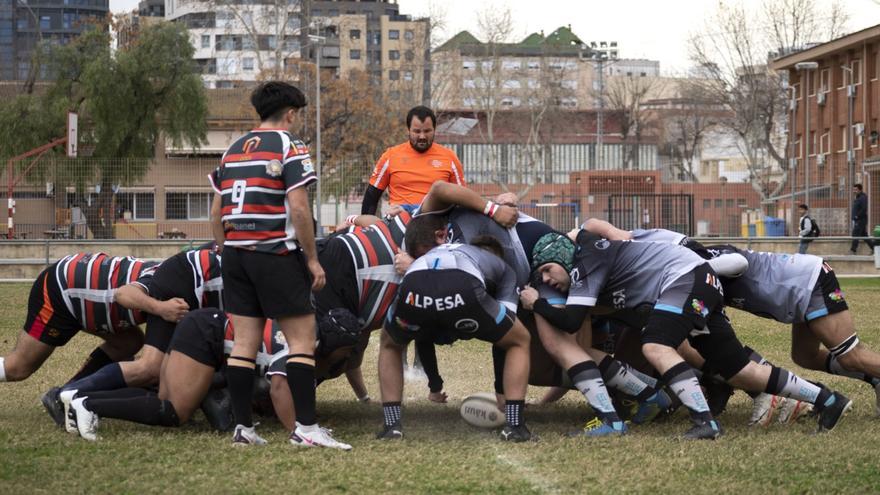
{"left": 0, "top": 0, "right": 109, "bottom": 80}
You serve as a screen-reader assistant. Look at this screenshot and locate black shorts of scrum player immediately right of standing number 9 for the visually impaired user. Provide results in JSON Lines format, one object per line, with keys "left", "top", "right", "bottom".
{"left": 315, "top": 237, "right": 360, "bottom": 315}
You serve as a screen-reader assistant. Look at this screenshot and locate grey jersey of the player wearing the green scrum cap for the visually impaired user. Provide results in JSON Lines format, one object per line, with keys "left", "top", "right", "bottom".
{"left": 566, "top": 231, "right": 705, "bottom": 309}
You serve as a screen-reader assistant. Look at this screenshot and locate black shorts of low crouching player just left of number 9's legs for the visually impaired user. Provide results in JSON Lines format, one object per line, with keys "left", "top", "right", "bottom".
{"left": 168, "top": 308, "right": 227, "bottom": 370}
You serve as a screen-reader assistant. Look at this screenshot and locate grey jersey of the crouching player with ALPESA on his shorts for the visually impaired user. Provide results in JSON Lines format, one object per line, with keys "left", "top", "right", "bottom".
{"left": 404, "top": 244, "right": 519, "bottom": 313}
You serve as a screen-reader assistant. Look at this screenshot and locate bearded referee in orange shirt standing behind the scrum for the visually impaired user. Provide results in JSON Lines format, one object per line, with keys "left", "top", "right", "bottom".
{"left": 361, "top": 106, "right": 467, "bottom": 215}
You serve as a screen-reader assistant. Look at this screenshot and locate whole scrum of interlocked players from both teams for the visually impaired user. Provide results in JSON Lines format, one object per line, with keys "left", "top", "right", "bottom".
{"left": 0, "top": 183, "right": 880, "bottom": 450}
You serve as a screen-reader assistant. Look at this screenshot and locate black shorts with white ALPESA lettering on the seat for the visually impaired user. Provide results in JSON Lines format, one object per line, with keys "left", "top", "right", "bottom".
{"left": 385, "top": 269, "right": 515, "bottom": 345}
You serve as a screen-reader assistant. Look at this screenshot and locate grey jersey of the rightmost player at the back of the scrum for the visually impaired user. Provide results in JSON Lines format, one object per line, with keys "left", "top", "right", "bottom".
{"left": 706, "top": 245, "right": 823, "bottom": 323}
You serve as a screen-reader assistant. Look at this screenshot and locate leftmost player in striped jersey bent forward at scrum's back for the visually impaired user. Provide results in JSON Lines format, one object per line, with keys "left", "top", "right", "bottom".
{"left": 0, "top": 253, "right": 180, "bottom": 400}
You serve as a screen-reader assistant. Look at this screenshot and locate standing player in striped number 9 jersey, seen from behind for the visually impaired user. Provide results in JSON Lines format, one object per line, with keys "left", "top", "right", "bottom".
{"left": 210, "top": 81, "right": 351, "bottom": 450}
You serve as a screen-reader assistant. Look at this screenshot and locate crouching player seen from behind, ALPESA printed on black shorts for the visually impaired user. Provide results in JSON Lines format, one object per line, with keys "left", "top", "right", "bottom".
{"left": 378, "top": 237, "right": 531, "bottom": 442}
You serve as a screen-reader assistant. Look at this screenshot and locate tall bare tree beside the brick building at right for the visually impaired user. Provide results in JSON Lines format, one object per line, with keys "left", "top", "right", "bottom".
{"left": 689, "top": 0, "right": 847, "bottom": 199}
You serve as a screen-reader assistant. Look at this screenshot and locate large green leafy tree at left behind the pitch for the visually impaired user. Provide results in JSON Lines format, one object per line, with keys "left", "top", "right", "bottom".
{"left": 0, "top": 23, "right": 207, "bottom": 238}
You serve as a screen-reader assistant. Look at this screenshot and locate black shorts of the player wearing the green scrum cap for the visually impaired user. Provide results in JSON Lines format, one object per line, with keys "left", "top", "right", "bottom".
{"left": 642, "top": 263, "right": 724, "bottom": 349}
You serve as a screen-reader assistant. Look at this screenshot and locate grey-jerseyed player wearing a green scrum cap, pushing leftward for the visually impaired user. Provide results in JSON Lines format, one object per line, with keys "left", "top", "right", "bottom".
{"left": 520, "top": 232, "right": 852, "bottom": 439}
